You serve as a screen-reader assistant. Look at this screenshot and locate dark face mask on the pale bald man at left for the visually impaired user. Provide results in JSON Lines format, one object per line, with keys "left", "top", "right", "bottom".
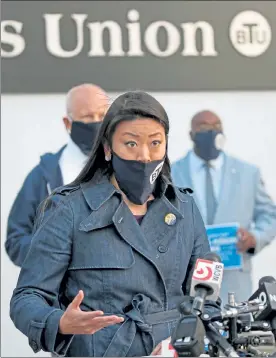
{"left": 71, "top": 121, "right": 102, "bottom": 155}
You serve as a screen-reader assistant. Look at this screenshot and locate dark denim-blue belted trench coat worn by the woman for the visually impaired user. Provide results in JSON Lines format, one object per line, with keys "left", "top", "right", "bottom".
{"left": 10, "top": 173, "right": 209, "bottom": 357}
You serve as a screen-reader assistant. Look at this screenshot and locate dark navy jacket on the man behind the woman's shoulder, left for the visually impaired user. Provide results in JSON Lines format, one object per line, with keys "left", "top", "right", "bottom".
{"left": 5, "top": 147, "right": 65, "bottom": 266}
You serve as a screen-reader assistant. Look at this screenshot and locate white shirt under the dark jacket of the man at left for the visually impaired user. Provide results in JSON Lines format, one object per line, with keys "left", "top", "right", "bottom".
{"left": 59, "top": 137, "right": 88, "bottom": 185}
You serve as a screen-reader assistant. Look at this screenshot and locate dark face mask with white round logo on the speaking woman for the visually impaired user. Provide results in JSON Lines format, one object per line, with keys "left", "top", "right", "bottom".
{"left": 112, "top": 152, "right": 164, "bottom": 205}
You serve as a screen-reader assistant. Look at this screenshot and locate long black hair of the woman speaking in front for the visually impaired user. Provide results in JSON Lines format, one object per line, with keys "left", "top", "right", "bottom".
{"left": 69, "top": 91, "right": 171, "bottom": 186}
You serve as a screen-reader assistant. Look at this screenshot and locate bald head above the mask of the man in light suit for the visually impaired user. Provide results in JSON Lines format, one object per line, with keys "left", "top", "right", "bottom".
{"left": 191, "top": 111, "right": 222, "bottom": 134}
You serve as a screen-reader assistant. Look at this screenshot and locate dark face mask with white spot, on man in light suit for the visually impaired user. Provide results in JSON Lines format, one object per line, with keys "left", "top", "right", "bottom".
{"left": 193, "top": 130, "right": 224, "bottom": 161}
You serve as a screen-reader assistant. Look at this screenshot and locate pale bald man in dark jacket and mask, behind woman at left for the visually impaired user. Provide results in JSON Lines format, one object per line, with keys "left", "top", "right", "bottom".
{"left": 5, "top": 84, "right": 109, "bottom": 266}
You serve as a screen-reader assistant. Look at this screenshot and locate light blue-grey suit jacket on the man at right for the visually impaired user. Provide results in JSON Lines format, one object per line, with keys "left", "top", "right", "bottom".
{"left": 172, "top": 152, "right": 276, "bottom": 302}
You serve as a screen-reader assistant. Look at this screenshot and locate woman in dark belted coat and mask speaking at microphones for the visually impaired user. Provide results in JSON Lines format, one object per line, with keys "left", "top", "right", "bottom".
{"left": 10, "top": 91, "right": 209, "bottom": 357}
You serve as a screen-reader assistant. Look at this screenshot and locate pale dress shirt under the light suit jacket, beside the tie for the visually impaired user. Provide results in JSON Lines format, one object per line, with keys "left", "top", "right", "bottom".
{"left": 189, "top": 151, "right": 224, "bottom": 222}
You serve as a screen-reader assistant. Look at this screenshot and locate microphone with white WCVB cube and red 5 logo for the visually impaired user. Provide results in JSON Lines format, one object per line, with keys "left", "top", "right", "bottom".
{"left": 190, "top": 252, "right": 224, "bottom": 315}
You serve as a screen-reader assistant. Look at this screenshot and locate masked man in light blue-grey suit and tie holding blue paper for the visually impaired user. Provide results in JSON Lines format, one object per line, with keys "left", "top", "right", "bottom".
{"left": 172, "top": 111, "right": 276, "bottom": 302}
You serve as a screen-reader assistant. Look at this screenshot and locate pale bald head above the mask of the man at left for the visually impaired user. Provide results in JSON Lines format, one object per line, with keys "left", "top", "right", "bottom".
{"left": 66, "top": 84, "right": 109, "bottom": 123}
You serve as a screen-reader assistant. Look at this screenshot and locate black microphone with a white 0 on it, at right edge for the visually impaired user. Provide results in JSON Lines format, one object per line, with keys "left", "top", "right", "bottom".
{"left": 249, "top": 276, "right": 276, "bottom": 337}
